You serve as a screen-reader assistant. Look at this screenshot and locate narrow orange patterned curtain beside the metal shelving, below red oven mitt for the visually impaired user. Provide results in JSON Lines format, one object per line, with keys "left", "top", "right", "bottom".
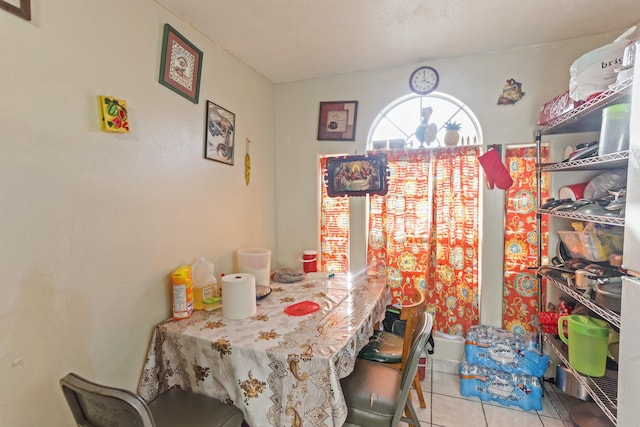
{"left": 502, "top": 147, "right": 549, "bottom": 334}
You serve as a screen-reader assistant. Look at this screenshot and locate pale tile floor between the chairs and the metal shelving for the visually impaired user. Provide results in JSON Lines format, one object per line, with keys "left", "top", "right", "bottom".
{"left": 410, "top": 360, "right": 571, "bottom": 427}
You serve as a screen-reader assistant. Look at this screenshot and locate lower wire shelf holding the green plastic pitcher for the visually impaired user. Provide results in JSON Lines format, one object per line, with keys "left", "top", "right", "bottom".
{"left": 544, "top": 334, "right": 618, "bottom": 425}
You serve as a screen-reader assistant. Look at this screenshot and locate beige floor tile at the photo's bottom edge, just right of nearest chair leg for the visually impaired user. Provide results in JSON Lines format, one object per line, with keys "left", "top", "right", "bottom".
{"left": 431, "top": 393, "right": 487, "bottom": 427}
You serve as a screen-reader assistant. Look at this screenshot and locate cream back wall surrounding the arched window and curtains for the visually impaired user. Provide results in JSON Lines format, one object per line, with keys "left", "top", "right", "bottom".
{"left": 276, "top": 31, "right": 621, "bottom": 360}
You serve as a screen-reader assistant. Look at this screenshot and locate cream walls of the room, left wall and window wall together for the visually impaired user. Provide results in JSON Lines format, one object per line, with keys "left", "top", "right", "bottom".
{"left": 0, "top": 0, "right": 632, "bottom": 427}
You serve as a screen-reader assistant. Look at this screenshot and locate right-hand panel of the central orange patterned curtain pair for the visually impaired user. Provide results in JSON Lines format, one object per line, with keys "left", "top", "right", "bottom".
{"left": 427, "top": 146, "right": 480, "bottom": 336}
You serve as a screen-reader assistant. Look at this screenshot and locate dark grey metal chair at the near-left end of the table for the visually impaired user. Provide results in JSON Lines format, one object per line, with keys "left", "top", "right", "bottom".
{"left": 60, "top": 373, "right": 244, "bottom": 427}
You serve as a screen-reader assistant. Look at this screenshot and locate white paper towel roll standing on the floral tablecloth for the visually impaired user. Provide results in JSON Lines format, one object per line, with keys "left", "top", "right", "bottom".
{"left": 222, "top": 273, "right": 256, "bottom": 319}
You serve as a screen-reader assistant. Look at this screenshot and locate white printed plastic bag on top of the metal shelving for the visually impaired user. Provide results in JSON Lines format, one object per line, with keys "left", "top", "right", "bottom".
{"left": 569, "top": 26, "right": 636, "bottom": 101}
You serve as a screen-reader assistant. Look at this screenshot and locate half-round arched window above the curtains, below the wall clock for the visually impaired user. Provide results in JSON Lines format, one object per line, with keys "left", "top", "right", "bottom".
{"left": 367, "top": 92, "right": 482, "bottom": 150}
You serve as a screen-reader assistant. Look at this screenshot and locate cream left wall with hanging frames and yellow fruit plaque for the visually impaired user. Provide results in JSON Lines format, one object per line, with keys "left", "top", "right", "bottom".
{"left": 0, "top": 0, "right": 277, "bottom": 427}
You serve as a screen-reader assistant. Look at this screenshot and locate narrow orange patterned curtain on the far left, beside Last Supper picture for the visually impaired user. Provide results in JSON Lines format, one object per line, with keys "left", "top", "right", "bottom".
{"left": 320, "top": 157, "right": 350, "bottom": 273}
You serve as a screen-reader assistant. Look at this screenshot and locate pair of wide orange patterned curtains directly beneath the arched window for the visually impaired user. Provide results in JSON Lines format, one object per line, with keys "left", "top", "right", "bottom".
{"left": 367, "top": 146, "right": 479, "bottom": 335}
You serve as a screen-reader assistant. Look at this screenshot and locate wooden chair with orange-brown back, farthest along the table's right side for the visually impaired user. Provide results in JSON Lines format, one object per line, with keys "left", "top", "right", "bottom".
{"left": 358, "top": 289, "right": 427, "bottom": 415}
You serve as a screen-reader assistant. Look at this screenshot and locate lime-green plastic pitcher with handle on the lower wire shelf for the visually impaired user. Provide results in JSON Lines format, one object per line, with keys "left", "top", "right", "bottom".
{"left": 558, "top": 314, "right": 609, "bottom": 377}
